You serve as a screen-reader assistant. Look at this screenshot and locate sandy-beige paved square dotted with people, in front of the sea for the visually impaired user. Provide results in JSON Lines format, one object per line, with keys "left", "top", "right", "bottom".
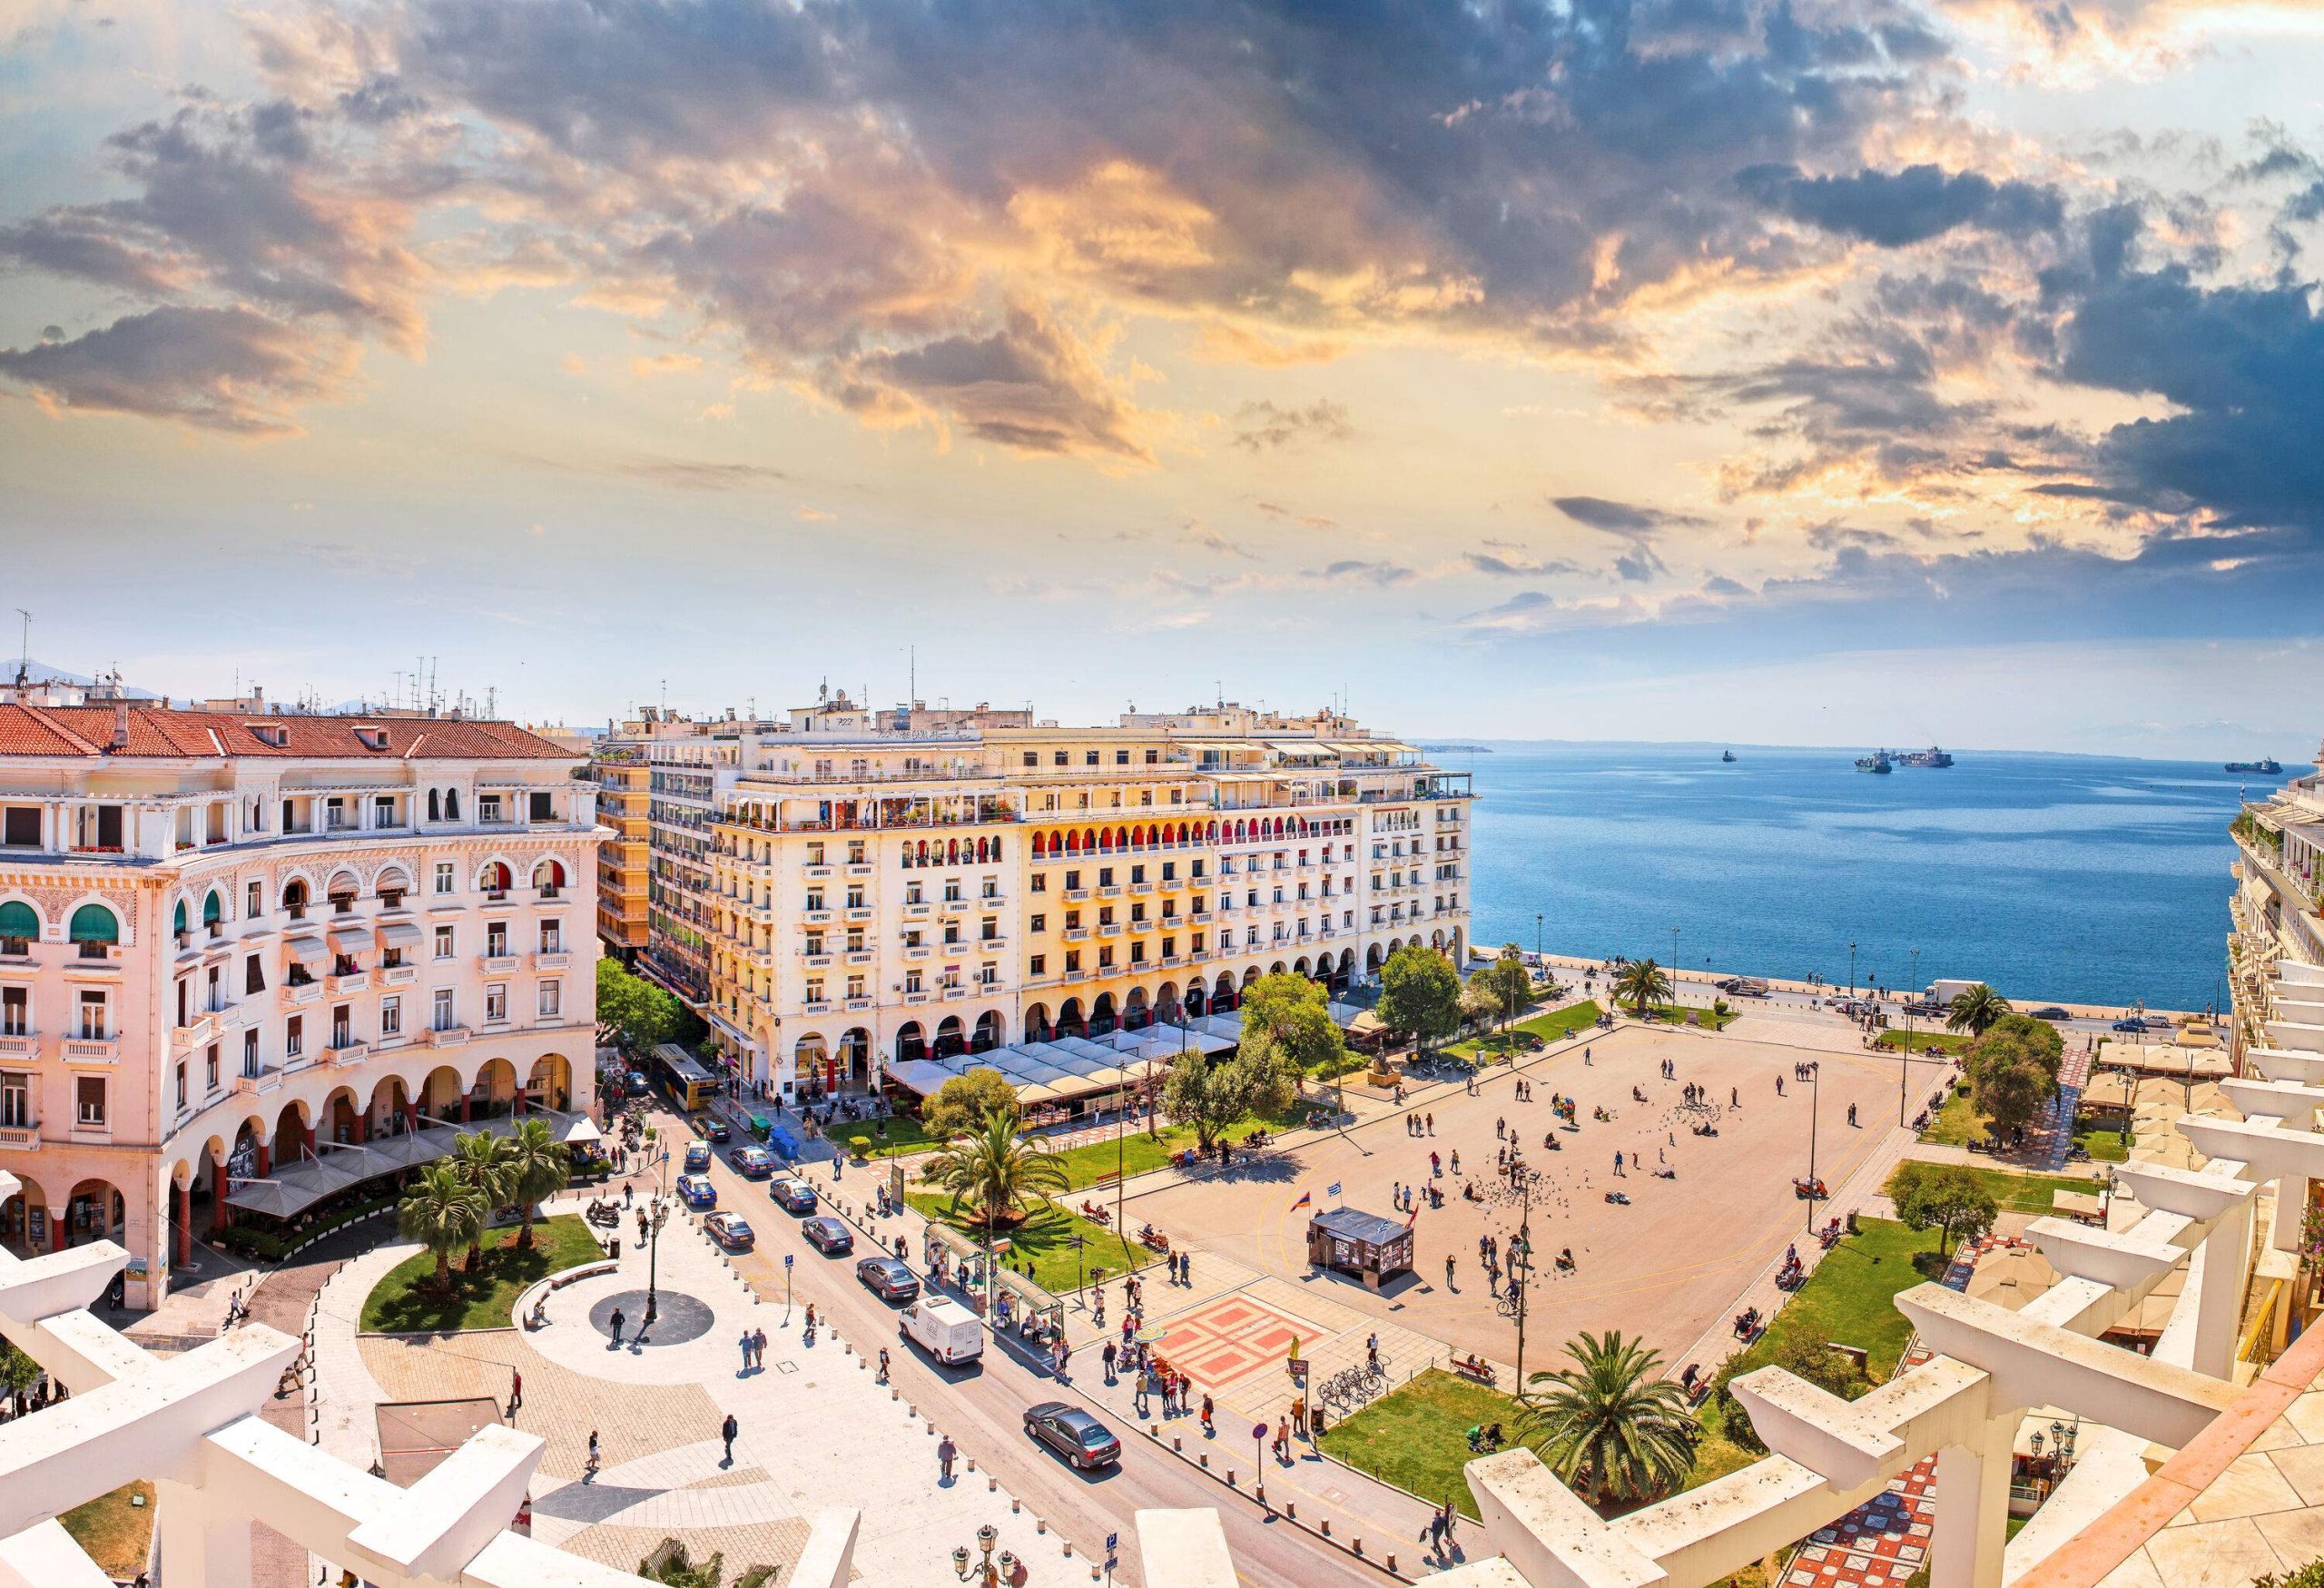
{"left": 1129, "top": 1025, "right": 1896, "bottom": 1367}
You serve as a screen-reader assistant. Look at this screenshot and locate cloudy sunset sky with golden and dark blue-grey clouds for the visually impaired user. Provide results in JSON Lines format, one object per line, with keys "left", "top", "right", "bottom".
{"left": 0, "top": 0, "right": 2324, "bottom": 760}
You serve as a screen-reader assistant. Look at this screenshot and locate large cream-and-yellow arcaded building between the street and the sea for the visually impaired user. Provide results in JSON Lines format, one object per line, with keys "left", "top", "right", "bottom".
{"left": 674, "top": 693, "right": 1471, "bottom": 1098}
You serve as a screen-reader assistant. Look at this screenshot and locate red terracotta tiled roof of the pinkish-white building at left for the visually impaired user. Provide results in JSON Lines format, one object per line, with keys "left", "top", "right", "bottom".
{"left": 0, "top": 705, "right": 574, "bottom": 760}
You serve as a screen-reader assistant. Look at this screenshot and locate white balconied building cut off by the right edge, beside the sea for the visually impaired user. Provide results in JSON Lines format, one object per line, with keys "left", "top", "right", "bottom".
{"left": 2226, "top": 749, "right": 2324, "bottom": 1070}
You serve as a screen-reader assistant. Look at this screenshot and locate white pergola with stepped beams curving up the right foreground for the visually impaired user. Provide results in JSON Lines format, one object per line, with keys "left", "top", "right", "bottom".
{"left": 1138, "top": 1074, "right": 2324, "bottom": 1588}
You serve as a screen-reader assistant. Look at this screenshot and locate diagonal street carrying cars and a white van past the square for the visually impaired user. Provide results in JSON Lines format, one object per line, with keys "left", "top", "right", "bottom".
{"left": 653, "top": 1111, "right": 1418, "bottom": 1588}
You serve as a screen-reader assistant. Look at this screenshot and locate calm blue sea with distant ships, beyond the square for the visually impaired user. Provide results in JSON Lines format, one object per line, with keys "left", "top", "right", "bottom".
{"left": 1434, "top": 744, "right": 2294, "bottom": 1009}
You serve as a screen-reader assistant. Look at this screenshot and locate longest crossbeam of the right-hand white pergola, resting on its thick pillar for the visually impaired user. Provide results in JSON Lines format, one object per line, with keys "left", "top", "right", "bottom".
{"left": 1896, "top": 1284, "right": 2236, "bottom": 1448}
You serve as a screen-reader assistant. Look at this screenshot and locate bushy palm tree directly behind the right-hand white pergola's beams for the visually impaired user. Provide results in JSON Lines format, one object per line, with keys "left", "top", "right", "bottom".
{"left": 1518, "top": 1330, "right": 1697, "bottom": 1509}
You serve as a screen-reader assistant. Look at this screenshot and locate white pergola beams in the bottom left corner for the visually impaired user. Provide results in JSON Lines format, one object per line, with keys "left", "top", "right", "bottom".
{"left": 0, "top": 1174, "right": 697, "bottom": 1588}
